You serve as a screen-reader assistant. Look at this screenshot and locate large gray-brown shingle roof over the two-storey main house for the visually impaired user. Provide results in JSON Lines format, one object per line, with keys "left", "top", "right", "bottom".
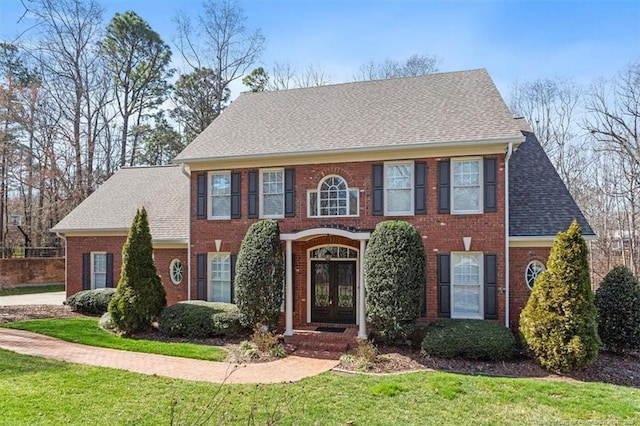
{"left": 174, "top": 69, "right": 522, "bottom": 163}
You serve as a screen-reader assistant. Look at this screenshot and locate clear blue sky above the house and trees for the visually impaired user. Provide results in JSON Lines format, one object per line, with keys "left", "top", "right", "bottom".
{"left": 0, "top": 0, "right": 640, "bottom": 97}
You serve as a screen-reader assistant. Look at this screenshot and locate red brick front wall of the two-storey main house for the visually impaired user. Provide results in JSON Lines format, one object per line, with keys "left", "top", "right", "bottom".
{"left": 191, "top": 156, "right": 505, "bottom": 325}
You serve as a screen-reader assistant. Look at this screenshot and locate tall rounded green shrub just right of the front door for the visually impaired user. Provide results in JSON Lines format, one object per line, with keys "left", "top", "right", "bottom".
{"left": 364, "top": 220, "right": 426, "bottom": 342}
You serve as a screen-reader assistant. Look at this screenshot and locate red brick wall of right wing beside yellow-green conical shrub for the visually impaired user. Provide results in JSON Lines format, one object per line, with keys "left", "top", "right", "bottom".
{"left": 509, "top": 247, "right": 551, "bottom": 330}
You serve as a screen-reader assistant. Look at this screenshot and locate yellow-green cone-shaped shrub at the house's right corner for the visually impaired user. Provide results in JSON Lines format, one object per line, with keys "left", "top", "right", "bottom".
{"left": 520, "top": 221, "right": 600, "bottom": 371}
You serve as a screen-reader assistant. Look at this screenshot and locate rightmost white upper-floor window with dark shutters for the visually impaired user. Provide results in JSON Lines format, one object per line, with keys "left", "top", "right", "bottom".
{"left": 451, "top": 158, "right": 482, "bottom": 214}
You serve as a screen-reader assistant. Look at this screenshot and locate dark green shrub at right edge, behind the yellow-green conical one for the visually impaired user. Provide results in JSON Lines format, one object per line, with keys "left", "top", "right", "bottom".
{"left": 596, "top": 266, "right": 640, "bottom": 353}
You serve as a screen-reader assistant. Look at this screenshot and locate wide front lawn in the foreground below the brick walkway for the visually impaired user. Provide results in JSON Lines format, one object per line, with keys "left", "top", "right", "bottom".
{"left": 0, "top": 350, "right": 640, "bottom": 425}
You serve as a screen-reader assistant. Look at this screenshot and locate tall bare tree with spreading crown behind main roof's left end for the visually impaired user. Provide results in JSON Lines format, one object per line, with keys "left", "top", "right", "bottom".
{"left": 175, "top": 0, "right": 265, "bottom": 115}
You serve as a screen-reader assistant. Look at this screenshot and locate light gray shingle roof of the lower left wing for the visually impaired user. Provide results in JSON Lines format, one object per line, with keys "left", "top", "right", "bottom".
{"left": 51, "top": 166, "right": 189, "bottom": 241}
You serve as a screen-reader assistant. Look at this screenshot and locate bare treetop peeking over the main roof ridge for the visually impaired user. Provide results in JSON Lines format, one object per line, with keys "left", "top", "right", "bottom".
{"left": 354, "top": 54, "right": 439, "bottom": 81}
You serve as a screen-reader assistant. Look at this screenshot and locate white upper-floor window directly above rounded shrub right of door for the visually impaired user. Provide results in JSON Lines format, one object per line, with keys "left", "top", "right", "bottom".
{"left": 384, "top": 163, "right": 413, "bottom": 216}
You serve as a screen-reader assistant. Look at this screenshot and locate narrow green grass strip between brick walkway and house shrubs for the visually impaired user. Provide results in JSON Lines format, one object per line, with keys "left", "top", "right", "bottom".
{"left": 2, "top": 317, "right": 226, "bottom": 361}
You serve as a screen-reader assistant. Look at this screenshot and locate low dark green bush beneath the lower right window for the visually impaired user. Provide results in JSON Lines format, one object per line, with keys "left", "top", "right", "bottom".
{"left": 422, "top": 319, "right": 515, "bottom": 361}
